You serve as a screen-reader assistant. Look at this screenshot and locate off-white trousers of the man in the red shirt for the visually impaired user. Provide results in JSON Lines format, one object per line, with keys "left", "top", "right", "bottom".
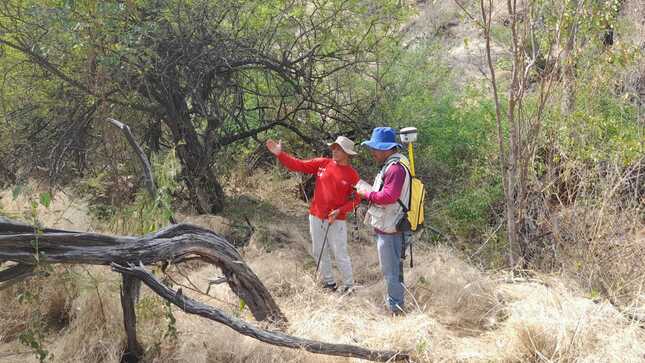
{"left": 309, "top": 214, "right": 354, "bottom": 287}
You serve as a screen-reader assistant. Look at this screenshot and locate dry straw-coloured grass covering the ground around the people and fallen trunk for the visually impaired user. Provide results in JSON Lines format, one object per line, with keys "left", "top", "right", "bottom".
{"left": 0, "top": 175, "right": 645, "bottom": 363}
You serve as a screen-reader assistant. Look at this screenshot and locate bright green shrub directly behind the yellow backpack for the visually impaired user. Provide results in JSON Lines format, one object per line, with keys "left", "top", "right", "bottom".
{"left": 368, "top": 44, "right": 503, "bottom": 239}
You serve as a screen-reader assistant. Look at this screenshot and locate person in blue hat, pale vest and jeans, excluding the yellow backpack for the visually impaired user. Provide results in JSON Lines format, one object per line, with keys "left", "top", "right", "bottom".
{"left": 357, "top": 127, "right": 411, "bottom": 315}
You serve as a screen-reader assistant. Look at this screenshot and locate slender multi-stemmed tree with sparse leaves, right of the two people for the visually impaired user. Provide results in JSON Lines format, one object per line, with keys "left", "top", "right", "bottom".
{"left": 457, "top": 0, "right": 640, "bottom": 267}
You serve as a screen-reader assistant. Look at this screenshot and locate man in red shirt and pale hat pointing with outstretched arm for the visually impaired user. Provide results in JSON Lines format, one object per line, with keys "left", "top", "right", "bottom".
{"left": 266, "top": 136, "right": 360, "bottom": 292}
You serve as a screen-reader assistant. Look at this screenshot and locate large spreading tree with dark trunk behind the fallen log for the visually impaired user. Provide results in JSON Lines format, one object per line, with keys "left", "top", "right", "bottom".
{"left": 0, "top": 0, "right": 405, "bottom": 212}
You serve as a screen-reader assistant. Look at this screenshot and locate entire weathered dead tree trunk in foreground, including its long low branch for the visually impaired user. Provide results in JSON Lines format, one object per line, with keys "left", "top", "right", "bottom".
{"left": 0, "top": 217, "right": 409, "bottom": 361}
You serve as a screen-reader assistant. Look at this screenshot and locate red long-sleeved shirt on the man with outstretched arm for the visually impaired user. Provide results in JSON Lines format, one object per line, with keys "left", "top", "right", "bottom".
{"left": 278, "top": 152, "right": 360, "bottom": 220}
